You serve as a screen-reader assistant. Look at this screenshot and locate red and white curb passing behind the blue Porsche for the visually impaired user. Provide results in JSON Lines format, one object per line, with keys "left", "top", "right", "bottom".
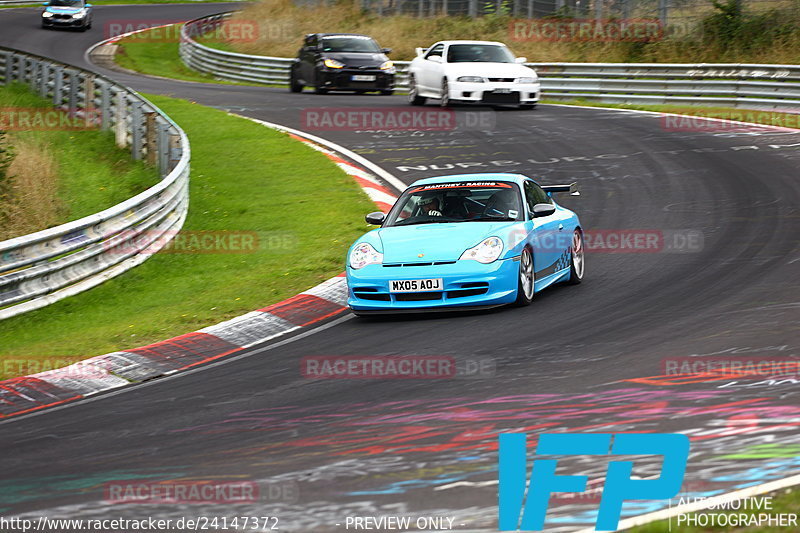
{"left": 0, "top": 121, "right": 405, "bottom": 420}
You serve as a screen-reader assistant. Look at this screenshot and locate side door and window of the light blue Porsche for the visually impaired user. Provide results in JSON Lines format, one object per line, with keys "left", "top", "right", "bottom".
{"left": 524, "top": 180, "right": 570, "bottom": 281}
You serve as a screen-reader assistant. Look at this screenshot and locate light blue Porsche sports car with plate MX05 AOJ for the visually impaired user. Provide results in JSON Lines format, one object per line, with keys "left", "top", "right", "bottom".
{"left": 347, "top": 174, "right": 584, "bottom": 315}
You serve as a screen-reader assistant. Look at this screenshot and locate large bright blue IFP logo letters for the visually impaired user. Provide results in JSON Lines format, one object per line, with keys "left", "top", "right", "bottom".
{"left": 499, "top": 433, "right": 689, "bottom": 531}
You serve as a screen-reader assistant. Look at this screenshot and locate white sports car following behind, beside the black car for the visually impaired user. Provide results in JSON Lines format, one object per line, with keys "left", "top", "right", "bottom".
{"left": 408, "top": 41, "right": 541, "bottom": 109}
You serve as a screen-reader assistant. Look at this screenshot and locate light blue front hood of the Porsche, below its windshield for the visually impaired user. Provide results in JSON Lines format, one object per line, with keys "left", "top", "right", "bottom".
{"left": 377, "top": 222, "right": 517, "bottom": 263}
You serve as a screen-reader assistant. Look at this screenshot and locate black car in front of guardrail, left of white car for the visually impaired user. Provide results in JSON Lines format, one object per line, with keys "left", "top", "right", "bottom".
{"left": 289, "top": 33, "right": 395, "bottom": 94}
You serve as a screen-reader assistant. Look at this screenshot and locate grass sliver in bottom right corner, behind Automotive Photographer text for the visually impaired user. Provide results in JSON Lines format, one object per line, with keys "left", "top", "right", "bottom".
{"left": 628, "top": 487, "right": 800, "bottom": 533}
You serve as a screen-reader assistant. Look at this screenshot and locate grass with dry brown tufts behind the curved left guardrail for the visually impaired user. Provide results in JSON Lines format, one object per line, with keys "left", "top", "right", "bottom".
{"left": 0, "top": 84, "right": 159, "bottom": 239}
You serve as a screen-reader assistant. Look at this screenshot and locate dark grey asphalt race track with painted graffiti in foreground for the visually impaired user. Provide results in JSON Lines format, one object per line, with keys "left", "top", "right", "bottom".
{"left": 0, "top": 4, "right": 800, "bottom": 532}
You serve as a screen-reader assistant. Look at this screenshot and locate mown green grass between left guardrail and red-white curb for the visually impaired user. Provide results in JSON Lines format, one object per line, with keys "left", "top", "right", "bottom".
{"left": 0, "top": 92, "right": 374, "bottom": 378}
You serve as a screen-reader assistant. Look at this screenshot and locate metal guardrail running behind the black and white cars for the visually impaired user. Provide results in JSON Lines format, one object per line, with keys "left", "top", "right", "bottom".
{"left": 180, "top": 13, "right": 800, "bottom": 111}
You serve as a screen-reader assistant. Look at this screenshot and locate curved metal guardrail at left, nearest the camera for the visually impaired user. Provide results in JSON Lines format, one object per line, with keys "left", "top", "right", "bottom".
{"left": 0, "top": 48, "right": 190, "bottom": 320}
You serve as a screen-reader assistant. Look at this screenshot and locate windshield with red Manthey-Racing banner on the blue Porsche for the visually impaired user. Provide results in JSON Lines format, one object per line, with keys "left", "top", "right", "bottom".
{"left": 383, "top": 181, "right": 523, "bottom": 227}
